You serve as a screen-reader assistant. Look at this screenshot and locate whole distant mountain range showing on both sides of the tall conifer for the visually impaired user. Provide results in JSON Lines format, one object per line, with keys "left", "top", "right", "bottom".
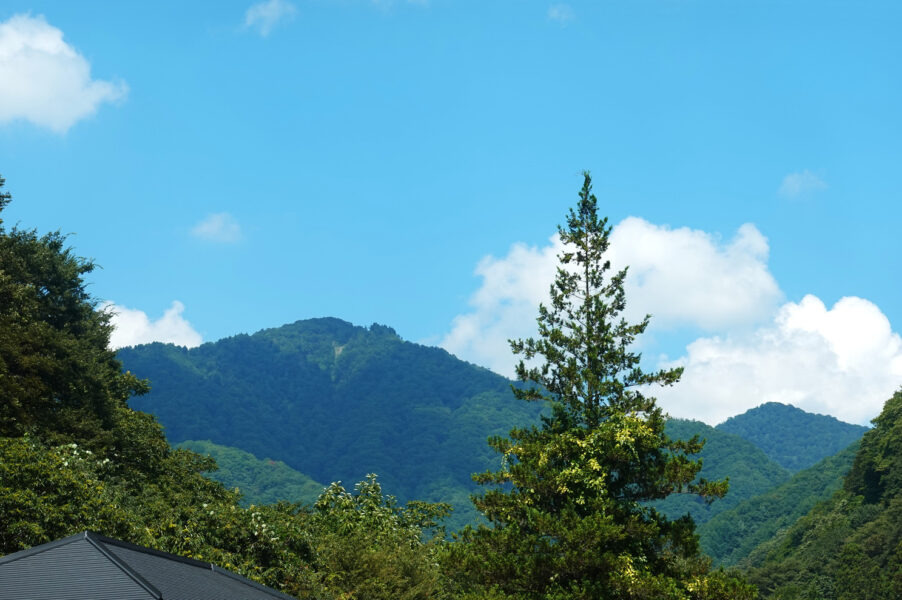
{"left": 119, "top": 318, "right": 865, "bottom": 538}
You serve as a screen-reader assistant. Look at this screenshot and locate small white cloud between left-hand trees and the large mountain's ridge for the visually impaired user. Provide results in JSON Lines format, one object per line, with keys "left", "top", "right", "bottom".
{"left": 101, "top": 300, "right": 203, "bottom": 350}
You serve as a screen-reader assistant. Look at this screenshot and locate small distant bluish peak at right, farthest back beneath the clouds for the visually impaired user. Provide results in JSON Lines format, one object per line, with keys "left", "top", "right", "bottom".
{"left": 717, "top": 402, "right": 868, "bottom": 473}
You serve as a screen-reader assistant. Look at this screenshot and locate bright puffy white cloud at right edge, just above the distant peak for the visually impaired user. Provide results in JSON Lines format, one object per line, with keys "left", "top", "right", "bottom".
{"left": 655, "top": 295, "right": 902, "bottom": 425}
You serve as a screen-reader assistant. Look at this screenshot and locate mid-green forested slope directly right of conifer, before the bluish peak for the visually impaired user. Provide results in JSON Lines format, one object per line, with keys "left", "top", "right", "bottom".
{"left": 651, "top": 419, "right": 790, "bottom": 524}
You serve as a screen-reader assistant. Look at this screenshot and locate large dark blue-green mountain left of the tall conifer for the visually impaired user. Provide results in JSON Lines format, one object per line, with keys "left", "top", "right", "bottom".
{"left": 119, "top": 318, "right": 540, "bottom": 528}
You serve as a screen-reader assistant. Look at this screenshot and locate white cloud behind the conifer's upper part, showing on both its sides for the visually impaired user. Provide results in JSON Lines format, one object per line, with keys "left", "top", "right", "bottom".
{"left": 441, "top": 217, "right": 780, "bottom": 375}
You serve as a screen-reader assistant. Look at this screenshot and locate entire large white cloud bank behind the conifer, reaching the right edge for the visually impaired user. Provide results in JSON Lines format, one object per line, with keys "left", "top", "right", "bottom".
{"left": 440, "top": 217, "right": 902, "bottom": 424}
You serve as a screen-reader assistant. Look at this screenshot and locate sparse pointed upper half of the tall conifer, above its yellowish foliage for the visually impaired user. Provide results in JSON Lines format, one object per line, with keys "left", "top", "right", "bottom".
{"left": 511, "top": 173, "right": 682, "bottom": 428}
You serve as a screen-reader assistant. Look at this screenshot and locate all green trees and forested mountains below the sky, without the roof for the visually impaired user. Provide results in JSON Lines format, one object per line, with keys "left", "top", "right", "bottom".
{"left": 0, "top": 174, "right": 902, "bottom": 600}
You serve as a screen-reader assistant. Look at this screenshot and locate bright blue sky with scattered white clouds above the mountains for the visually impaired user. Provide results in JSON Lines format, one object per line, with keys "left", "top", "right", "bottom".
{"left": 0, "top": 0, "right": 902, "bottom": 422}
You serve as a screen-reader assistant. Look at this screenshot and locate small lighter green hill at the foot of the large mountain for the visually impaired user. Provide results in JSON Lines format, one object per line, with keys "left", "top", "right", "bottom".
{"left": 178, "top": 440, "right": 325, "bottom": 505}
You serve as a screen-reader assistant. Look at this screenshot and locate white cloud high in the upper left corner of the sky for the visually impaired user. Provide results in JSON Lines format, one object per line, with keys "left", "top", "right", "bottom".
{"left": 0, "top": 15, "right": 128, "bottom": 133}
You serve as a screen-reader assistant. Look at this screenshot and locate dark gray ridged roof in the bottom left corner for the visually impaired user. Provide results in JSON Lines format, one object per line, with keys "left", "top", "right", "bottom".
{"left": 0, "top": 531, "right": 295, "bottom": 600}
